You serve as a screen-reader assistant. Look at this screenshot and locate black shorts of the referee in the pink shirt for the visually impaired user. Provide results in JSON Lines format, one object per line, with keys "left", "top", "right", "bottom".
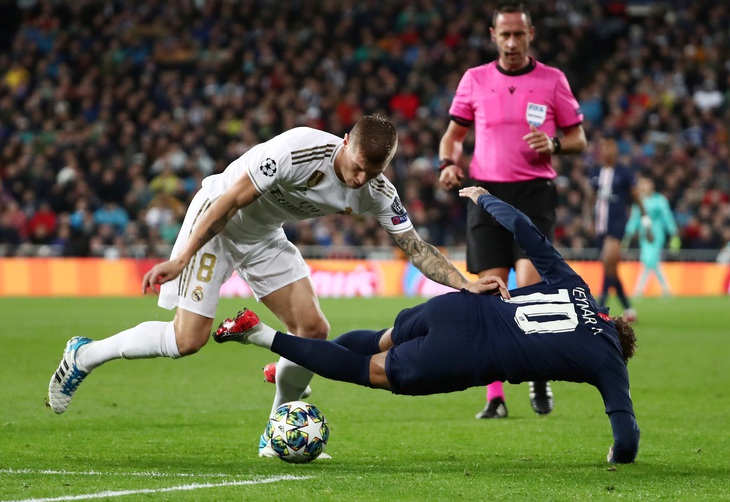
{"left": 466, "top": 178, "right": 558, "bottom": 274}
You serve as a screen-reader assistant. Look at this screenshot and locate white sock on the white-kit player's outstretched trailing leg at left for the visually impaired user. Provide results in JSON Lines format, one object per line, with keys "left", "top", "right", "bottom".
{"left": 76, "top": 321, "right": 180, "bottom": 371}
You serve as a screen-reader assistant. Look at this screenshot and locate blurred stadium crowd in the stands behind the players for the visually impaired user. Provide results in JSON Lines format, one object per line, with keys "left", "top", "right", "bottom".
{"left": 0, "top": 0, "right": 730, "bottom": 257}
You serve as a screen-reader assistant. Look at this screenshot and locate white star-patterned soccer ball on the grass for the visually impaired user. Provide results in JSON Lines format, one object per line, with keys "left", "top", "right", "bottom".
{"left": 264, "top": 401, "right": 330, "bottom": 464}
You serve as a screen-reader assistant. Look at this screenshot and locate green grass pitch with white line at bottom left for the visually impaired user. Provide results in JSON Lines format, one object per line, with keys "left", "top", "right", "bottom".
{"left": 0, "top": 298, "right": 730, "bottom": 501}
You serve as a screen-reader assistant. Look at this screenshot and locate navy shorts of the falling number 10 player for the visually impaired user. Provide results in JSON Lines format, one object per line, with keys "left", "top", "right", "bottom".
{"left": 385, "top": 291, "right": 491, "bottom": 396}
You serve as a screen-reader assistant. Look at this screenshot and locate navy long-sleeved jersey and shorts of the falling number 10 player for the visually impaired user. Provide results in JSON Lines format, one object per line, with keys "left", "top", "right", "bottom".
{"left": 386, "top": 195, "right": 633, "bottom": 415}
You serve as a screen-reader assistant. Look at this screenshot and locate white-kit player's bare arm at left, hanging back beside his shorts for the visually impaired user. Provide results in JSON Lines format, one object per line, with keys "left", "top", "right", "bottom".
{"left": 142, "top": 173, "right": 260, "bottom": 293}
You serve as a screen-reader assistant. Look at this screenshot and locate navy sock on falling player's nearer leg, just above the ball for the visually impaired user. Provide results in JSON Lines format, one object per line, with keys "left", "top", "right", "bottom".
{"left": 271, "top": 331, "right": 370, "bottom": 387}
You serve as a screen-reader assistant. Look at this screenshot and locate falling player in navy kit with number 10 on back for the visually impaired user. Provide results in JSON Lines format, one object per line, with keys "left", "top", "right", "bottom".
{"left": 213, "top": 187, "right": 639, "bottom": 463}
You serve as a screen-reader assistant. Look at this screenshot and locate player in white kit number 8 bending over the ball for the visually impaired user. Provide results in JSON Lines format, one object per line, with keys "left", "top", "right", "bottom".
{"left": 48, "top": 116, "right": 489, "bottom": 455}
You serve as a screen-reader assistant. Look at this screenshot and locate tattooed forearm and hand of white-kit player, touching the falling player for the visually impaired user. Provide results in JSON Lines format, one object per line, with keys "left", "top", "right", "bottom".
{"left": 390, "top": 229, "right": 509, "bottom": 298}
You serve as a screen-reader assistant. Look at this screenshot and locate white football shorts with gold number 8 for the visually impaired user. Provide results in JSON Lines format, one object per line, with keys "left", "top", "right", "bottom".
{"left": 157, "top": 189, "right": 310, "bottom": 318}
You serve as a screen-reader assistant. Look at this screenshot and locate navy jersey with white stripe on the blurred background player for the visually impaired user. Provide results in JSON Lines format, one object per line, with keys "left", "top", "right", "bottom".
{"left": 590, "top": 165, "right": 636, "bottom": 239}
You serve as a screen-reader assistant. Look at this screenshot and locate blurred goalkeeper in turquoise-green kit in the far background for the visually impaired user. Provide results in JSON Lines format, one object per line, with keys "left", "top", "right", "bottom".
{"left": 624, "top": 177, "right": 681, "bottom": 297}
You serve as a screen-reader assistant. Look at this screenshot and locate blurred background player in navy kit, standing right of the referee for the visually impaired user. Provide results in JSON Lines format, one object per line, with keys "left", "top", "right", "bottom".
{"left": 590, "top": 137, "right": 651, "bottom": 322}
